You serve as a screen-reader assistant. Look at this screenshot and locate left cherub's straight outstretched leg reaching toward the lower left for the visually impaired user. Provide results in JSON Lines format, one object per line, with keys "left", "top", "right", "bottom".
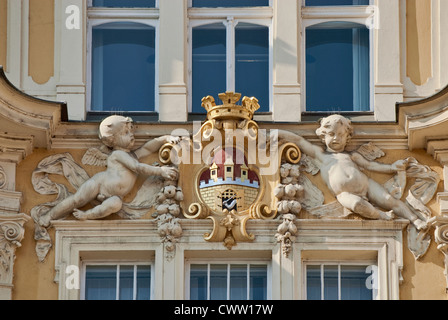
{"left": 39, "top": 180, "right": 99, "bottom": 227}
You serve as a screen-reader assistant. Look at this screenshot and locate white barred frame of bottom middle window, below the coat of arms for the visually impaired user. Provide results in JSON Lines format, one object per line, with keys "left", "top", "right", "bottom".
{"left": 185, "top": 259, "right": 272, "bottom": 300}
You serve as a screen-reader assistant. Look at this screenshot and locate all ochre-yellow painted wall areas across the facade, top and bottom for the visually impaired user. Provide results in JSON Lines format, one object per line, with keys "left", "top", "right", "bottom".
{"left": 6, "top": 0, "right": 448, "bottom": 300}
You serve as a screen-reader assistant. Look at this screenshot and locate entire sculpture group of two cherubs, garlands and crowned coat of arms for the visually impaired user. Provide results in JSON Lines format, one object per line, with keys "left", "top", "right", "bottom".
{"left": 31, "top": 92, "right": 440, "bottom": 261}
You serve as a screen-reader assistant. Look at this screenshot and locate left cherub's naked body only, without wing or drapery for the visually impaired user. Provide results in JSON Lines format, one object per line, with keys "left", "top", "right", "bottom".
{"left": 39, "top": 116, "right": 178, "bottom": 227}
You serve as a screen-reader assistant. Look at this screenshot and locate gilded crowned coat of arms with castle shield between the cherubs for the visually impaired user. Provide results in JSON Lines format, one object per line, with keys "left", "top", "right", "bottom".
{"left": 183, "top": 92, "right": 301, "bottom": 250}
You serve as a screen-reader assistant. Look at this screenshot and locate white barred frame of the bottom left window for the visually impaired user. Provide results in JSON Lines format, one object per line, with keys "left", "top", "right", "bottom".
{"left": 80, "top": 260, "right": 154, "bottom": 300}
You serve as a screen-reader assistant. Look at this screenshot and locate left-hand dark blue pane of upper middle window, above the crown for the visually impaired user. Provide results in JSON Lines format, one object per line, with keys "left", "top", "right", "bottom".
{"left": 192, "top": 23, "right": 227, "bottom": 113}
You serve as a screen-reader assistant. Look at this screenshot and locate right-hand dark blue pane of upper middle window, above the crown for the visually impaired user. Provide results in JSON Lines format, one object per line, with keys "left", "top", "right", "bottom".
{"left": 235, "top": 23, "right": 269, "bottom": 112}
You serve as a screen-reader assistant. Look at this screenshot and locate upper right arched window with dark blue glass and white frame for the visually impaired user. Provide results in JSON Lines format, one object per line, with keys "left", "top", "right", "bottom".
{"left": 302, "top": 0, "right": 379, "bottom": 113}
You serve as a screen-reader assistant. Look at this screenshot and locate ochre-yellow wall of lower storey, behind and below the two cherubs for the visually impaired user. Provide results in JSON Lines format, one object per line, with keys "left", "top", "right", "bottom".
{"left": 9, "top": 145, "right": 448, "bottom": 300}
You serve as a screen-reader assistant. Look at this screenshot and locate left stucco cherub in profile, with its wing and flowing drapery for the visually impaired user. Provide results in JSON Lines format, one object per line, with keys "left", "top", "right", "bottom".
{"left": 31, "top": 116, "right": 180, "bottom": 261}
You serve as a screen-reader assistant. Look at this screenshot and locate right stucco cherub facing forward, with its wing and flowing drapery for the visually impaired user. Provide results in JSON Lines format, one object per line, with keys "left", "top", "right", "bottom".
{"left": 279, "top": 115, "right": 440, "bottom": 256}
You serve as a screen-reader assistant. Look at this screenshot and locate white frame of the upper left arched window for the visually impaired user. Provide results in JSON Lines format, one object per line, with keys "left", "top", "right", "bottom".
{"left": 86, "top": 0, "right": 159, "bottom": 113}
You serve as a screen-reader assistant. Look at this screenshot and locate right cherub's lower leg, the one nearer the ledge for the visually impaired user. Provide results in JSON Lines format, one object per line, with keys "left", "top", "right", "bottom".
{"left": 336, "top": 192, "right": 393, "bottom": 220}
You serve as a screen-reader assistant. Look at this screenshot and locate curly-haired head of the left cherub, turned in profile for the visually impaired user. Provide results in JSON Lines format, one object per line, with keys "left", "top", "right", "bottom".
{"left": 99, "top": 115, "right": 135, "bottom": 149}
